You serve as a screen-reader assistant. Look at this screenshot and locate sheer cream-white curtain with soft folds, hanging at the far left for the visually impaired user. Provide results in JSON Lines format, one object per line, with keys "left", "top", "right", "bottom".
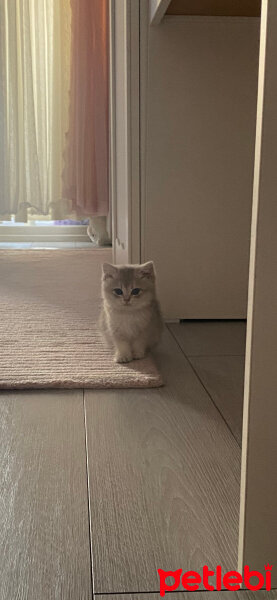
{"left": 0, "top": 0, "right": 71, "bottom": 220}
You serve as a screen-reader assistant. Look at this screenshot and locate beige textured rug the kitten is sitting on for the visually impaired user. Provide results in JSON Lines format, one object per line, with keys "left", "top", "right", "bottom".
{"left": 0, "top": 249, "right": 162, "bottom": 389}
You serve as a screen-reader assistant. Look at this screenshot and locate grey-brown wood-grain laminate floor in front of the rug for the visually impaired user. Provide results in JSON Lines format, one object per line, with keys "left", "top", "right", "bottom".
{"left": 0, "top": 322, "right": 272, "bottom": 600}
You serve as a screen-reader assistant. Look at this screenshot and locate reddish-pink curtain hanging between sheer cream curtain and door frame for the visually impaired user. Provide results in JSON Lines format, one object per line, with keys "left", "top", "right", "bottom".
{"left": 63, "top": 0, "right": 109, "bottom": 216}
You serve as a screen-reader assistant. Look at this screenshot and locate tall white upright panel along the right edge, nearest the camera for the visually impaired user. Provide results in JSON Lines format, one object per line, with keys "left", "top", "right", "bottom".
{"left": 239, "top": 0, "right": 277, "bottom": 587}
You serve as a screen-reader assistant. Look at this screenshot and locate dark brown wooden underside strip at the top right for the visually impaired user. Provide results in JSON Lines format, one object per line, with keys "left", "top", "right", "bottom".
{"left": 166, "top": 0, "right": 261, "bottom": 17}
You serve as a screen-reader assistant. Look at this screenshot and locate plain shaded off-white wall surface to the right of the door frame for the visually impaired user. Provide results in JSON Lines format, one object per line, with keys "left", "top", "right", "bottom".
{"left": 142, "top": 17, "right": 259, "bottom": 318}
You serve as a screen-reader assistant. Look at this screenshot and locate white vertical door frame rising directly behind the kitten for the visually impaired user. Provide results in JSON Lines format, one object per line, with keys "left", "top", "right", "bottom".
{"left": 109, "top": 0, "right": 141, "bottom": 264}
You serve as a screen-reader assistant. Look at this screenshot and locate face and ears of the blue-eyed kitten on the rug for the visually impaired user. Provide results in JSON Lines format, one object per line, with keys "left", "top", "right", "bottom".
{"left": 102, "top": 262, "right": 155, "bottom": 312}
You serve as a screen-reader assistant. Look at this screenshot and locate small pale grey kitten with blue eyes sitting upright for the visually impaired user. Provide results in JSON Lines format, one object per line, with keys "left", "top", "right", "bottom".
{"left": 99, "top": 262, "right": 163, "bottom": 363}
